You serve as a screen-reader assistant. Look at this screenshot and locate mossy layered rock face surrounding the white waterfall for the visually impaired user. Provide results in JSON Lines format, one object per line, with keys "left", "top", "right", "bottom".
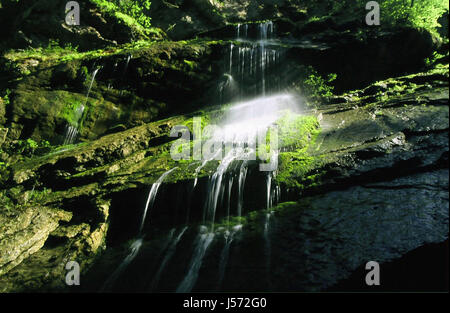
{"left": 0, "top": 1, "right": 449, "bottom": 292}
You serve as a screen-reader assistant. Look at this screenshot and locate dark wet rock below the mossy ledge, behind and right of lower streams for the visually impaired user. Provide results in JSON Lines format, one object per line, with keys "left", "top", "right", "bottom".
{"left": 74, "top": 169, "right": 449, "bottom": 292}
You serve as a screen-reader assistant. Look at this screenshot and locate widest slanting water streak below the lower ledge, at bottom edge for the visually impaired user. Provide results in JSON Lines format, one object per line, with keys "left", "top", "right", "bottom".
{"left": 176, "top": 226, "right": 214, "bottom": 292}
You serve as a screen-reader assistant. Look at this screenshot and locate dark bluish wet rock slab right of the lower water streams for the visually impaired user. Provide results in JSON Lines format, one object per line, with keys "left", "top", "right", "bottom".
{"left": 271, "top": 170, "right": 449, "bottom": 291}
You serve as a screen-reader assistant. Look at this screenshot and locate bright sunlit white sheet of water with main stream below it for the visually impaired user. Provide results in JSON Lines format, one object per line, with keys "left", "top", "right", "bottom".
{"left": 177, "top": 80, "right": 297, "bottom": 292}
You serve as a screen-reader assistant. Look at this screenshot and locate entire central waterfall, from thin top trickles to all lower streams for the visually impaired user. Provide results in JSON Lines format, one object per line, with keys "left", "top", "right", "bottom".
{"left": 99, "top": 22, "right": 299, "bottom": 292}
